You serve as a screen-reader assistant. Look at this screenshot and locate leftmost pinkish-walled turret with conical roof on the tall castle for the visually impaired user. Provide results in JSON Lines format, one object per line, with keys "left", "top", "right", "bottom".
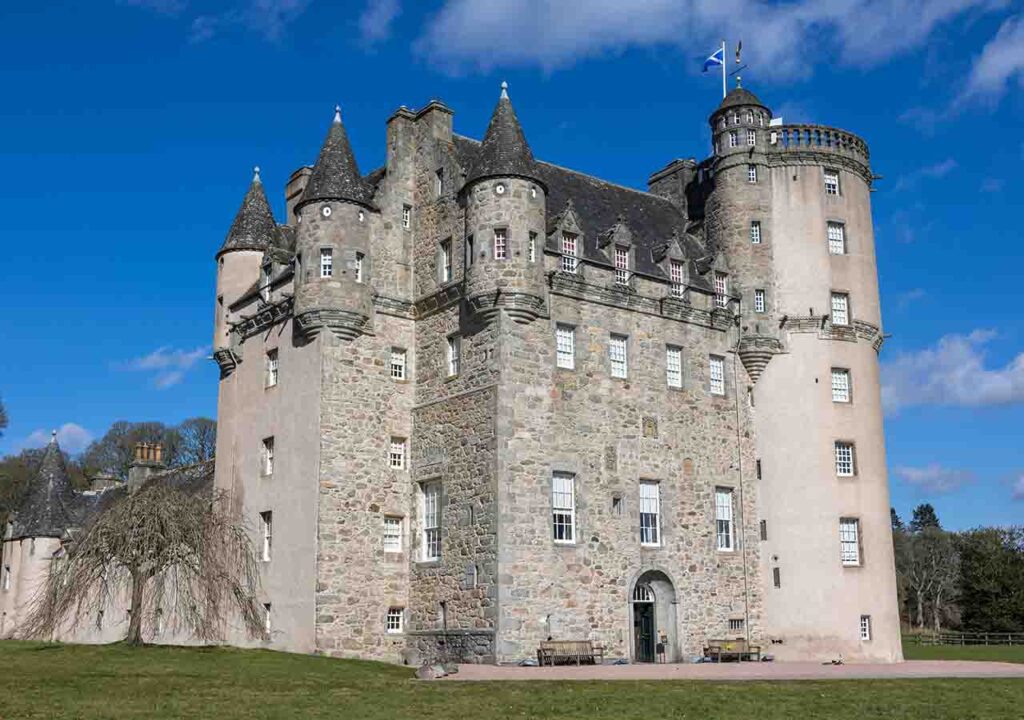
{"left": 213, "top": 168, "right": 278, "bottom": 376}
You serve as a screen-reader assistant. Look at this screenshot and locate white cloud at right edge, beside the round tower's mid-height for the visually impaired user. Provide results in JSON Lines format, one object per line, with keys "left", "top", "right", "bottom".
{"left": 882, "top": 330, "right": 1024, "bottom": 413}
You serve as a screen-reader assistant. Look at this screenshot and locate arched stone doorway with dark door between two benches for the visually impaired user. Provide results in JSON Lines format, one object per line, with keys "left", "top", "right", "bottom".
{"left": 630, "top": 570, "right": 677, "bottom": 663}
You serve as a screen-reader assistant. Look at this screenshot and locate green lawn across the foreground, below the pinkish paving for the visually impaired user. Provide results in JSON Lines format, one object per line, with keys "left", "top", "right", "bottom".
{"left": 0, "top": 642, "right": 1024, "bottom": 720}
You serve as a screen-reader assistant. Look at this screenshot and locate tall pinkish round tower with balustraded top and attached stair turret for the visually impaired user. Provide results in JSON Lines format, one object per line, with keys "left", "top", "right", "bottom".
{"left": 707, "top": 82, "right": 901, "bottom": 661}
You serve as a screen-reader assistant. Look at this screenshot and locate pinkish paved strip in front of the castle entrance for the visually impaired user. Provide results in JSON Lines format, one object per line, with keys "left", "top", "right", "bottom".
{"left": 445, "top": 661, "right": 1024, "bottom": 681}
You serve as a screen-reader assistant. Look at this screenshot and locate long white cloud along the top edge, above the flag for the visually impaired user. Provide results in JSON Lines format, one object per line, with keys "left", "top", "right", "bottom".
{"left": 417, "top": 0, "right": 1008, "bottom": 77}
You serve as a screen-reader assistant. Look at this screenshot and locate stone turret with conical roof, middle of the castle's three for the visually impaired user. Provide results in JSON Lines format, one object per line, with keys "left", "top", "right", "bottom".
{"left": 295, "top": 108, "right": 374, "bottom": 340}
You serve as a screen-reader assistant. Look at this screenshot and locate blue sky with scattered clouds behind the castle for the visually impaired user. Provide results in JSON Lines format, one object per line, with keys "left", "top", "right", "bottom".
{"left": 0, "top": 0, "right": 1024, "bottom": 527}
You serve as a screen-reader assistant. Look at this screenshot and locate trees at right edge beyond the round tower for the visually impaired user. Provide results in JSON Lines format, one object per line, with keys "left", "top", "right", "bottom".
{"left": 891, "top": 503, "right": 1024, "bottom": 633}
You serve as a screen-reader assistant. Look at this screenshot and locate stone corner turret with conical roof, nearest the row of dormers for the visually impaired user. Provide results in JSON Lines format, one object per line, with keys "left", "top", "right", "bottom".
{"left": 462, "top": 83, "right": 547, "bottom": 323}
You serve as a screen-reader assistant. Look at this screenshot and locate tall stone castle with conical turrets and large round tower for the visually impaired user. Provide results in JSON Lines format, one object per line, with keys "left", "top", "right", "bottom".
{"left": 6, "top": 81, "right": 901, "bottom": 663}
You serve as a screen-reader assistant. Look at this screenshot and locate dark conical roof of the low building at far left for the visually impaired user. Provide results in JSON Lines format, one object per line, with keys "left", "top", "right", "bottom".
{"left": 12, "top": 432, "right": 75, "bottom": 540}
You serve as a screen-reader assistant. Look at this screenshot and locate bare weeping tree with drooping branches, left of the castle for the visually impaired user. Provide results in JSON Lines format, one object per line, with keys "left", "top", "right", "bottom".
{"left": 22, "top": 483, "right": 265, "bottom": 645}
